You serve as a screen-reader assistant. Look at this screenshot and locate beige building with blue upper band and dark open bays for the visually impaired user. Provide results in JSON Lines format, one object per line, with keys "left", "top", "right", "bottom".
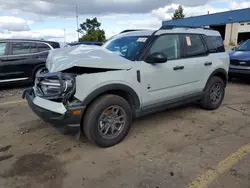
{"left": 162, "top": 8, "right": 250, "bottom": 46}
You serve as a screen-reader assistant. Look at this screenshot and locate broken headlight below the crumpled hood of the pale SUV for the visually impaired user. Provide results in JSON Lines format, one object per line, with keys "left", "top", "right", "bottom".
{"left": 35, "top": 72, "right": 75, "bottom": 99}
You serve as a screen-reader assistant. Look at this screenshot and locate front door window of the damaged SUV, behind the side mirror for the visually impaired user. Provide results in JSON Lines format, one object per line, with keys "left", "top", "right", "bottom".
{"left": 149, "top": 35, "right": 180, "bottom": 60}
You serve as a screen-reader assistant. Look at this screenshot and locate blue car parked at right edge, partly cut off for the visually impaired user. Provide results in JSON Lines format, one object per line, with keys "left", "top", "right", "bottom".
{"left": 229, "top": 39, "right": 250, "bottom": 78}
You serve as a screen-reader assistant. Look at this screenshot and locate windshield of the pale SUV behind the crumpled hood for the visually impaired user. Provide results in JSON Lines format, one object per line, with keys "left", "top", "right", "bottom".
{"left": 103, "top": 36, "right": 148, "bottom": 61}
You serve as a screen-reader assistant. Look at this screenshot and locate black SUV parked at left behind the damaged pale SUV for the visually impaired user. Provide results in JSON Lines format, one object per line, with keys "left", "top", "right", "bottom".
{"left": 0, "top": 39, "right": 60, "bottom": 84}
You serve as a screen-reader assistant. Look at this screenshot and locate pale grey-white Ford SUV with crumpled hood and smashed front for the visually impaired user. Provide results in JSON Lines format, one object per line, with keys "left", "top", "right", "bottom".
{"left": 23, "top": 26, "right": 229, "bottom": 147}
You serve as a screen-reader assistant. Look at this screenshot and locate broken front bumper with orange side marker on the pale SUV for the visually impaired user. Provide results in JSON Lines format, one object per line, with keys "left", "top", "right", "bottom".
{"left": 23, "top": 88, "right": 85, "bottom": 128}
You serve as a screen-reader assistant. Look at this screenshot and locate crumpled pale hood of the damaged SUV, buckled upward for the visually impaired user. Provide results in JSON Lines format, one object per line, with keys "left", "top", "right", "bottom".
{"left": 46, "top": 46, "right": 133, "bottom": 72}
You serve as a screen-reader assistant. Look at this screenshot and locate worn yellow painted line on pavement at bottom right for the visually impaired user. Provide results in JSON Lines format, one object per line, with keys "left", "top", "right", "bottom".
{"left": 187, "top": 144, "right": 250, "bottom": 188}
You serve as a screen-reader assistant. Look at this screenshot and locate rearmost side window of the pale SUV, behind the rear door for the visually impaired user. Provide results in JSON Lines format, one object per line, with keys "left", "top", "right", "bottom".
{"left": 204, "top": 36, "right": 225, "bottom": 53}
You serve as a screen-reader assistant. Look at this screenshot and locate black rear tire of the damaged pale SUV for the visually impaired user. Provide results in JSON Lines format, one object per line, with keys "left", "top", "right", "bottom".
{"left": 201, "top": 76, "right": 225, "bottom": 110}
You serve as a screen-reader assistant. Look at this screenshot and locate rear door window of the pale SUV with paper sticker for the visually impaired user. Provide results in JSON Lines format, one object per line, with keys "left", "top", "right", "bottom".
{"left": 182, "top": 34, "right": 206, "bottom": 57}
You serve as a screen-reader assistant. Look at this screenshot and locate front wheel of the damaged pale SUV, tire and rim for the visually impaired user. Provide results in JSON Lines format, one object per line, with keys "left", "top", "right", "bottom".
{"left": 82, "top": 94, "right": 132, "bottom": 147}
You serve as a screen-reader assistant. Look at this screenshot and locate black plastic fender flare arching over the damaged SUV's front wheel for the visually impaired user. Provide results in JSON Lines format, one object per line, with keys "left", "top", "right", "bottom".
{"left": 82, "top": 84, "right": 140, "bottom": 109}
